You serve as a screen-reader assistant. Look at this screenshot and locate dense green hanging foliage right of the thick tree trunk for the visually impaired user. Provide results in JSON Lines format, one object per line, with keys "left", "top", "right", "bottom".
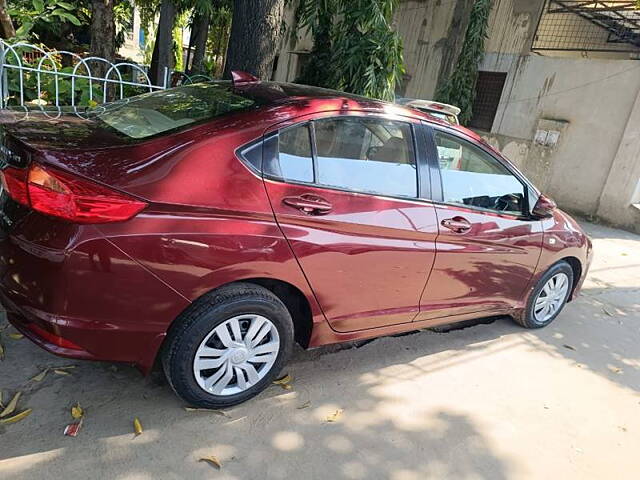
{"left": 296, "top": 0, "right": 404, "bottom": 100}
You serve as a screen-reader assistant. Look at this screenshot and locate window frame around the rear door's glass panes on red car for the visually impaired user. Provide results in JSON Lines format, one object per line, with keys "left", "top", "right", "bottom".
{"left": 261, "top": 111, "right": 431, "bottom": 201}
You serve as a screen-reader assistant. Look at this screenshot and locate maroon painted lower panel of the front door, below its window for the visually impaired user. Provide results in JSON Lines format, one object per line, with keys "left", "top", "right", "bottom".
{"left": 416, "top": 205, "right": 543, "bottom": 320}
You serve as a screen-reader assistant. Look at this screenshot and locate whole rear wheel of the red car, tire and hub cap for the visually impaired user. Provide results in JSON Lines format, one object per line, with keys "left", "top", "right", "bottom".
{"left": 162, "top": 283, "right": 293, "bottom": 408}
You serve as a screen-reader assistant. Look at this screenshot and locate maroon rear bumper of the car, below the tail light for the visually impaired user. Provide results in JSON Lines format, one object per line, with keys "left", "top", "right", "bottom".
{"left": 0, "top": 216, "right": 189, "bottom": 373}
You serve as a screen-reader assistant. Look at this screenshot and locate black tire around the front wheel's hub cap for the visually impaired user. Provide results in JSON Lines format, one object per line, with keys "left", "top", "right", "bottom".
{"left": 514, "top": 261, "right": 573, "bottom": 328}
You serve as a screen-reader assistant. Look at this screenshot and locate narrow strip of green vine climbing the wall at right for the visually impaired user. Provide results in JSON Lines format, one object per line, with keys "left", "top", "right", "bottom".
{"left": 436, "top": 0, "right": 491, "bottom": 125}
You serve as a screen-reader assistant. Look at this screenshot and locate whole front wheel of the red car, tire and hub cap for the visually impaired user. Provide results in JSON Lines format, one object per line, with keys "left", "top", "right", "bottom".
{"left": 514, "top": 261, "right": 573, "bottom": 328}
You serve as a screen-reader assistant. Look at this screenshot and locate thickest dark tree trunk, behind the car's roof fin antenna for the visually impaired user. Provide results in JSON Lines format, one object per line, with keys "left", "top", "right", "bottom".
{"left": 224, "top": 0, "right": 284, "bottom": 80}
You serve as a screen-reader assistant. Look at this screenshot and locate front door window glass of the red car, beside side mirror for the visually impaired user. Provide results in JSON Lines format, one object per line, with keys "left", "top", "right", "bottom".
{"left": 435, "top": 131, "right": 525, "bottom": 215}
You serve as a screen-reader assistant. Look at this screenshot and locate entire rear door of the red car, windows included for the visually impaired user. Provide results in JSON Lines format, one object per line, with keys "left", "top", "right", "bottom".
{"left": 263, "top": 114, "right": 438, "bottom": 332}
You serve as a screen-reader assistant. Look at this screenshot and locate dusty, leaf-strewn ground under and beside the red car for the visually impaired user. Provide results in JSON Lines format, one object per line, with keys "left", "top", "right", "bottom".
{"left": 0, "top": 224, "right": 640, "bottom": 480}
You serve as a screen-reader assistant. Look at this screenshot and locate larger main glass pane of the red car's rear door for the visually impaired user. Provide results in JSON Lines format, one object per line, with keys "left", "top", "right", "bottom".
{"left": 313, "top": 117, "right": 418, "bottom": 198}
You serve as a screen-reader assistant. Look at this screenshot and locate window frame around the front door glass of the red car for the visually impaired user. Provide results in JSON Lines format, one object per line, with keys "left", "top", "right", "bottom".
{"left": 423, "top": 122, "right": 537, "bottom": 221}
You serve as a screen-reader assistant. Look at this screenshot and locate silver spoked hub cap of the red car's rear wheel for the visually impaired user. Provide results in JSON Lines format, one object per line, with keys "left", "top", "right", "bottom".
{"left": 193, "top": 315, "right": 280, "bottom": 395}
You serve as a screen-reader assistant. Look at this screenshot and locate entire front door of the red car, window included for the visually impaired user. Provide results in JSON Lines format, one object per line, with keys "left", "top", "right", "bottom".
{"left": 416, "top": 125, "right": 542, "bottom": 320}
